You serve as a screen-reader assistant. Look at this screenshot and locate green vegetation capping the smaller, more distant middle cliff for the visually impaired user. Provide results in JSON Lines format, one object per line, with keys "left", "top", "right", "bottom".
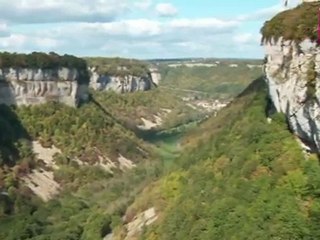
{"left": 85, "top": 57, "right": 149, "bottom": 76}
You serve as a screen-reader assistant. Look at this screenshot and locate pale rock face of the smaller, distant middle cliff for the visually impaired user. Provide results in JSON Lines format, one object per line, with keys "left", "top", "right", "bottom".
{"left": 89, "top": 67, "right": 161, "bottom": 93}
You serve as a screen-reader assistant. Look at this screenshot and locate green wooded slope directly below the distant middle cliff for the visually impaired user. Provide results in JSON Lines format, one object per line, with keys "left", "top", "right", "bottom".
{"left": 94, "top": 89, "right": 203, "bottom": 130}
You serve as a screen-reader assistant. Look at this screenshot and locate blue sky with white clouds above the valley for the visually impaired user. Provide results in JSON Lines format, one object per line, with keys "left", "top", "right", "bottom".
{"left": 0, "top": 0, "right": 299, "bottom": 59}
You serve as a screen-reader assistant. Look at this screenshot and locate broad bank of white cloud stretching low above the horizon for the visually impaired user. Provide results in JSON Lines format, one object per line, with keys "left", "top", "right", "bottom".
{"left": 0, "top": 18, "right": 242, "bottom": 58}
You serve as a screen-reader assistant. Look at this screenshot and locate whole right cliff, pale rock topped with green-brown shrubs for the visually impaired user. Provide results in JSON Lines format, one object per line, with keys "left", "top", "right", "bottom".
{"left": 262, "top": 3, "right": 320, "bottom": 152}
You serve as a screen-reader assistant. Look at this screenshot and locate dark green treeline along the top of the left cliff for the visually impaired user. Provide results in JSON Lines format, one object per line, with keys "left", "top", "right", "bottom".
{"left": 0, "top": 52, "right": 87, "bottom": 69}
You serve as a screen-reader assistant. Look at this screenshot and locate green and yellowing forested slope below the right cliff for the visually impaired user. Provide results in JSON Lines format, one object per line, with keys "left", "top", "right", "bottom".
{"left": 114, "top": 79, "right": 320, "bottom": 240}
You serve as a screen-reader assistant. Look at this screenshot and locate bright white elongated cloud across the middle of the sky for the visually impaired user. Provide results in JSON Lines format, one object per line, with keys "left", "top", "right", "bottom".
{"left": 62, "top": 18, "right": 238, "bottom": 42}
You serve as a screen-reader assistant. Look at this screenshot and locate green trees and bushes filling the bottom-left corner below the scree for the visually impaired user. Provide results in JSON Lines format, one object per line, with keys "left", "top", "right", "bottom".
{"left": 0, "top": 152, "right": 157, "bottom": 240}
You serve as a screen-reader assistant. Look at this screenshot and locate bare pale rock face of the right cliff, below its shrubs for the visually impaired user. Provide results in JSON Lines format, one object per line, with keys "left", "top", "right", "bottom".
{"left": 264, "top": 38, "right": 320, "bottom": 152}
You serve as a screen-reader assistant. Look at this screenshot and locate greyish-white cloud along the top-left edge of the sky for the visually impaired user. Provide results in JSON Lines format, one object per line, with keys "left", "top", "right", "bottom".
{"left": 0, "top": 0, "right": 129, "bottom": 23}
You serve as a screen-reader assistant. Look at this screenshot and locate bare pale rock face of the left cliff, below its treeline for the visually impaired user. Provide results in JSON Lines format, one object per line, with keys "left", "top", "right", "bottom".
{"left": 0, "top": 67, "right": 89, "bottom": 106}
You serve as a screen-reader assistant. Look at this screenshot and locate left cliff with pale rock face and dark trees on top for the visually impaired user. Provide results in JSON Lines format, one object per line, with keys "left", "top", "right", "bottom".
{"left": 0, "top": 53, "right": 89, "bottom": 106}
